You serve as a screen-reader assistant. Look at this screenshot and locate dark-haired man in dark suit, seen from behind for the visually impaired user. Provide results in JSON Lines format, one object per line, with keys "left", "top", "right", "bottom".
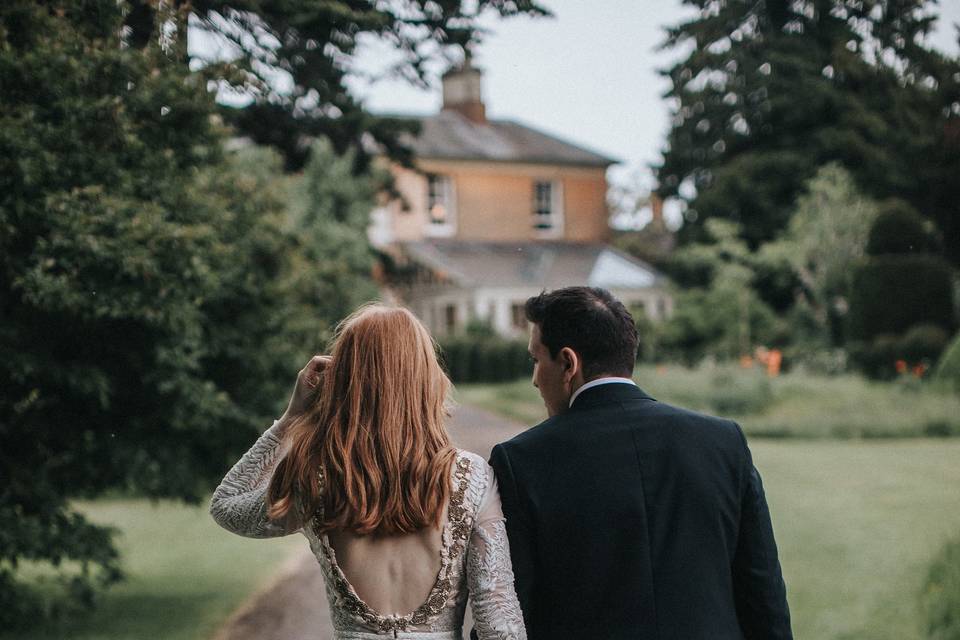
{"left": 490, "top": 287, "right": 792, "bottom": 640}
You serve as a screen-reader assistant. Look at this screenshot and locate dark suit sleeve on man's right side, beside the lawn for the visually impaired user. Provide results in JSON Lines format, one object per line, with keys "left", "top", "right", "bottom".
{"left": 733, "top": 425, "right": 793, "bottom": 640}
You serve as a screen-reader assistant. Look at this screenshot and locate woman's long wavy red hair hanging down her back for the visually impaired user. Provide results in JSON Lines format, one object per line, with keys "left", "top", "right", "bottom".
{"left": 267, "top": 304, "right": 456, "bottom": 534}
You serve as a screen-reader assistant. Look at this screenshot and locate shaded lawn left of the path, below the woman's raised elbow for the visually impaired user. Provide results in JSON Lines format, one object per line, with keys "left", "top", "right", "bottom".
{"left": 0, "top": 499, "right": 306, "bottom": 640}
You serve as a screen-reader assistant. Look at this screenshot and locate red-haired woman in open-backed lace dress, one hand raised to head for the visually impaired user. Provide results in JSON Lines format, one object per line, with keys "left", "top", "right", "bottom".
{"left": 210, "top": 304, "right": 526, "bottom": 640}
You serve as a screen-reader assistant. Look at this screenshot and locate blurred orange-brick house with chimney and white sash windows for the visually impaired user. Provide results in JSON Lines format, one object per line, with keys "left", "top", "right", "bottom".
{"left": 369, "top": 58, "right": 673, "bottom": 336}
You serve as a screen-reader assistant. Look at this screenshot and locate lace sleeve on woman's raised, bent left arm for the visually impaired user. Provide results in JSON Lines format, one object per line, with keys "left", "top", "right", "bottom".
{"left": 210, "top": 420, "right": 297, "bottom": 538}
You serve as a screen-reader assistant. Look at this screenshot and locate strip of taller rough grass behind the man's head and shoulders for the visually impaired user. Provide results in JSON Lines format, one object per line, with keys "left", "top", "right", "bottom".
{"left": 457, "top": 365, "right": 960, "bottom": 438}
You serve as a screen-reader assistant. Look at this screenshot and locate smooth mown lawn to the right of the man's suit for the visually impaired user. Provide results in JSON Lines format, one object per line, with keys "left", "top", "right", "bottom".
{"left": 751, "top": 439, "right": 960, "bottom": 640}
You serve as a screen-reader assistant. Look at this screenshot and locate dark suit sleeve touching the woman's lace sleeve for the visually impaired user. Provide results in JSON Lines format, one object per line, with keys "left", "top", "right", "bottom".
{"left": 490, "top": 445, "right": 537, "bottom": 631}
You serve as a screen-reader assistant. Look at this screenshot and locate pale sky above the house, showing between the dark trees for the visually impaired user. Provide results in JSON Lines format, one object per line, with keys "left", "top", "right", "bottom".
{"left": 349, "top": 0, "right": 960, "bottom": 226}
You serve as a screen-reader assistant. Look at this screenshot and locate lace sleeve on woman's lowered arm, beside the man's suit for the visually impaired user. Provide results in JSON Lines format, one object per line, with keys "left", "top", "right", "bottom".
{"left": 467, "top": 465, "right": 527, "bottom": 640}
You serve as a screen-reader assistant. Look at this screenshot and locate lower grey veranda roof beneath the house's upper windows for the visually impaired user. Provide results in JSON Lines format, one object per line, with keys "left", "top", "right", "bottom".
{"left": 403, "top": 240, "right": 664, "bottom": 289}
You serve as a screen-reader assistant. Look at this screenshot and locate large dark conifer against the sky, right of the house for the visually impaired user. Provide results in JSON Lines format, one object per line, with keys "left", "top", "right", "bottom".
{"left": 658, "top": 0, "right": 960, "bottom": 263}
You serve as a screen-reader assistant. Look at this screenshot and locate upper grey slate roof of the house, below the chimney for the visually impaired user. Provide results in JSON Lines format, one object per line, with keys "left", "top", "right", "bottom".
{"left": 394, "top": 109, "right": 619, "bottom": 167}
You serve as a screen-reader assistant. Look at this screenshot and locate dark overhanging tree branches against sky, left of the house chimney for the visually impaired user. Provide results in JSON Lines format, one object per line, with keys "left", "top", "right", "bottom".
{"left": 127, "top": 0, "right": 546, "bottom": 168}
